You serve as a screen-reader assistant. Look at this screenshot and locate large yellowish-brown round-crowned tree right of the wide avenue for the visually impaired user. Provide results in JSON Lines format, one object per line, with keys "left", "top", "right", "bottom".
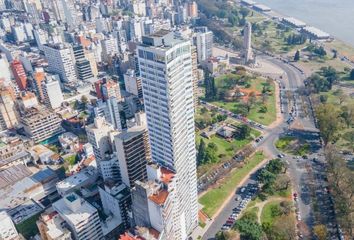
{"left": 316, "top": 104, "right": 343, "bottom": 145}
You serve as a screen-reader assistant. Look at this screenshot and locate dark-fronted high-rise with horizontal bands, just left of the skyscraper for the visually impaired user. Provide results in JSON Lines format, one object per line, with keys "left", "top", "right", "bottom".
{"left": 114, "top": 113, "right": 150, "bottom": 187}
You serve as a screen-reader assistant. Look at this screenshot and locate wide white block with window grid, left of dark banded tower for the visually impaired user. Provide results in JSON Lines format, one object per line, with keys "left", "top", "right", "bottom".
{"left": 43, "top": 44, "right": 77, "bottom": 83}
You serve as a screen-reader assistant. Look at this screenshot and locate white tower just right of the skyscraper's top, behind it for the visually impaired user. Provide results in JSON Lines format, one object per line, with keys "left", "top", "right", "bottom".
{"left": 194, "top": 27, "right": 213, "bottom": 64}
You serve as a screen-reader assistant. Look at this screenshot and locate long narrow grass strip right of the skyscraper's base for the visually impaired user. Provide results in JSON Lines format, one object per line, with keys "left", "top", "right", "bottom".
{"left": 199, "top": 152, "right": 264, "bottom": 217}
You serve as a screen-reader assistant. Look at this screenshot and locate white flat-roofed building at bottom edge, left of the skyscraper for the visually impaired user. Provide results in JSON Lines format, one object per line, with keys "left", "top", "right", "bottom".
{"left": 53, "top": 193, "right": 103, "bottom": 240}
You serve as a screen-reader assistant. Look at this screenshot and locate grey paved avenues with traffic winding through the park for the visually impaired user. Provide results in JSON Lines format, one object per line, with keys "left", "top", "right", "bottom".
{"left": 203, "top": 56, "right": 338, "bottom": 240}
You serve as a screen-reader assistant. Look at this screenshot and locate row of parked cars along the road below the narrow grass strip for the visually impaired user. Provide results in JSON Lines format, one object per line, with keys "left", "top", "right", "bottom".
{"left": 221, "top": 183, "right": 259, "bottom": 231}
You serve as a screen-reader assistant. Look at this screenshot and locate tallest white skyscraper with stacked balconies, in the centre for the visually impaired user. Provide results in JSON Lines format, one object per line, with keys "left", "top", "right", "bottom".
{"left": 137, "top": 30, "right": 198, "bottom": 239}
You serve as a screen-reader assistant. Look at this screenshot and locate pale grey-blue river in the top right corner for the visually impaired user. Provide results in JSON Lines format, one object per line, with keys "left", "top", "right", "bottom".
{"left": 255, "top": 0, "right": 354, "bottom": 47}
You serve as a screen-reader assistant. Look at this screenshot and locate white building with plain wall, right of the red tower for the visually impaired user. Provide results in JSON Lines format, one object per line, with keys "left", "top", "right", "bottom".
{"left": 42, "top": 75, "right": 64, "bottom": 109}
